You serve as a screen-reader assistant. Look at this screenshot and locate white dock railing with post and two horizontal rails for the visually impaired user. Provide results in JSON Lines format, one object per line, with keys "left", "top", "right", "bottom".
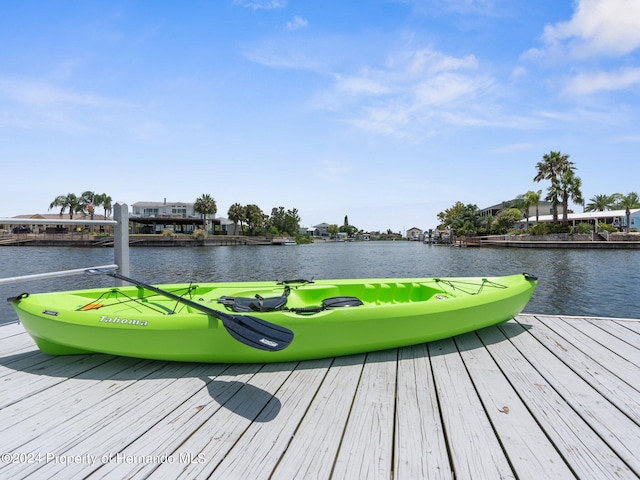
{"left": 0, "top": 202, "right": 129, "bottom": 286}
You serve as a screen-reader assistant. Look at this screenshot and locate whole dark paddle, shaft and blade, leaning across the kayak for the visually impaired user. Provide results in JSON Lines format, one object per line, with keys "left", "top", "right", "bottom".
{"left": 86, "top": 268, "right": 293, "bottom": 352}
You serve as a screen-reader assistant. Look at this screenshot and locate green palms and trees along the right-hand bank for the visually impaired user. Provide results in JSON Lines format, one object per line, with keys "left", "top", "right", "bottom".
{"left": 437, "top": 151, "right": 640, "bottom": 235}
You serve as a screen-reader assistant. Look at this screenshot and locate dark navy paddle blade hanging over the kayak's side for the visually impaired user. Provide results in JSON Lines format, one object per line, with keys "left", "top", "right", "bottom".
{"left": 218, "top": 312, "right": 293, "bottom": 352}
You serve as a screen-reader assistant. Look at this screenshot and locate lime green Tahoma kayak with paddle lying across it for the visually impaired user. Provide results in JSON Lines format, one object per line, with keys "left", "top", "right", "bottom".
{"left": 8, "top": 273, "right": 537, "bottom": 363}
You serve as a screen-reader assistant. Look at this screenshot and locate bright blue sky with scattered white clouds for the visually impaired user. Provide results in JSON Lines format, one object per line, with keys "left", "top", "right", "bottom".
{"left": 0, "top": 0, "right": 640, "bottom": 231}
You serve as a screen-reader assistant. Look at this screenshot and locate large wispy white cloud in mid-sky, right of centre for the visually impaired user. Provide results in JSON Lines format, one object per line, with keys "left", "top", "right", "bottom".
{"left": 321, "top": 48, "right": 493, "bottom": 138}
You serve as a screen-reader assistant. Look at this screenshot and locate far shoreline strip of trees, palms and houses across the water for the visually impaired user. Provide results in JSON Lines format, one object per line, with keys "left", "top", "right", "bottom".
{"left": 0, "top": 151, "right": 640, "bottom": 246}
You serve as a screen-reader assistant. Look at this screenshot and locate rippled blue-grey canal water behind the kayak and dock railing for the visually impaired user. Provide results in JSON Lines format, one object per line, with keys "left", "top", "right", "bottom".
{"left": 0, "top": 242, "right": 640, "bottom": 323}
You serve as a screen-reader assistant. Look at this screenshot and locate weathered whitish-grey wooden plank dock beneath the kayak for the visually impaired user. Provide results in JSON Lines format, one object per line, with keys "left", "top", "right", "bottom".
{"left": 0, "top": 315, "right": 640, "bottom": 480}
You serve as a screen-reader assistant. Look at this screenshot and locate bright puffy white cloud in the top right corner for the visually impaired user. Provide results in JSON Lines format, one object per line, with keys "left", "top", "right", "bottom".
{"left": 543, "top": 0, "right": 640, "bottom": 57}
